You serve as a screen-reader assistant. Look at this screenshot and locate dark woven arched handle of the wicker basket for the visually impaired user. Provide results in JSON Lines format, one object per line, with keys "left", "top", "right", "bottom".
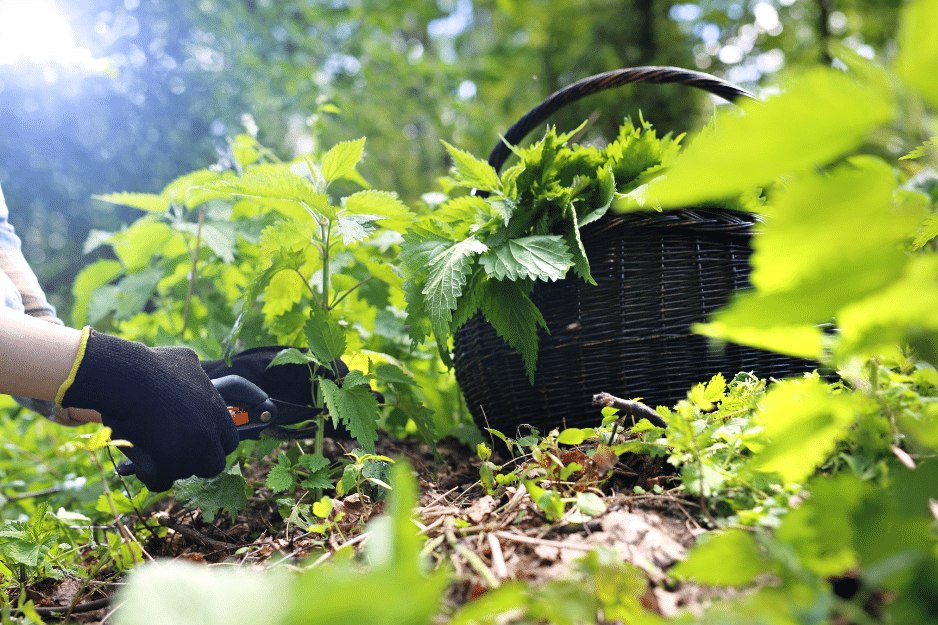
{"left": 489, "top": 66, "right": 756, "bottom": 171}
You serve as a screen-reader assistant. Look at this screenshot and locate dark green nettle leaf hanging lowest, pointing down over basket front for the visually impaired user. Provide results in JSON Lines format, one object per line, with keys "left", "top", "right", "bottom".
{"left": 482, "top": 280, "right": 547, "bottom": 384}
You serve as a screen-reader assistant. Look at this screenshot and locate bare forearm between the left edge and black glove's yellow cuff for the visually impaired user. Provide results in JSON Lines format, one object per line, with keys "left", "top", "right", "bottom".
{"left": 0, "top": 307, "right": 81, "bottom": 400}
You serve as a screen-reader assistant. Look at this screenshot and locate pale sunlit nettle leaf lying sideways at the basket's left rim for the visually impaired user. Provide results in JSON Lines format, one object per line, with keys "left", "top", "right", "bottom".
{"left": 481, "top": 235, "right": 573, "bottom": 281}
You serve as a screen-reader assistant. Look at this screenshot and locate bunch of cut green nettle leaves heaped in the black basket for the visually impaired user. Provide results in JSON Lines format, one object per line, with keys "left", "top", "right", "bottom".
{"left": 401, "top": 120, "right": 683, "bottom": 383}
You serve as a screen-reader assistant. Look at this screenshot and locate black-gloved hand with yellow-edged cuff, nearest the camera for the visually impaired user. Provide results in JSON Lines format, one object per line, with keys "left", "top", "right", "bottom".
{"left": 56, "top": 328, "right": 239, "bottom": 492}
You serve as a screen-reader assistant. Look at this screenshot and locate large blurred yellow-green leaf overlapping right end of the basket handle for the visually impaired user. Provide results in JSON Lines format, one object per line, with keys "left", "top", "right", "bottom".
{"left": 649, "top": 68, "right": 892, "bottom": 207}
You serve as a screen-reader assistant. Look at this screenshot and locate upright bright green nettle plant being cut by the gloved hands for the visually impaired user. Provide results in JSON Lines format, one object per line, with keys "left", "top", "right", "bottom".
{"left": 89, "top": 135, "right": 434, "bottom": 509}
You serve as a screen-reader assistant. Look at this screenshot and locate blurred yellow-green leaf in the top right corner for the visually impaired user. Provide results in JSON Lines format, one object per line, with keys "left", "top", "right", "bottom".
{"left": 896, "top": 0, "right": 938, "bottom": 107}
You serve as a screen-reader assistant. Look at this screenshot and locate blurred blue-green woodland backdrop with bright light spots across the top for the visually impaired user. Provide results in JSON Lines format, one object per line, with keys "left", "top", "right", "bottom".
{"left": 0, "top": 0, "right": 898, "bottom": 314}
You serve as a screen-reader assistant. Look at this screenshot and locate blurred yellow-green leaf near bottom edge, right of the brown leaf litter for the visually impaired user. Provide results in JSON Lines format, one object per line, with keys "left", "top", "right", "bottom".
{"left": 669, "top": 529, "right": 770, "bottom": 586}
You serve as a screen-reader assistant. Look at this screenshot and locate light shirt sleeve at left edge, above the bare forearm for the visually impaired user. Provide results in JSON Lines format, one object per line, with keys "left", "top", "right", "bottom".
{"left": 0, "top": 183, "right": 62, "bottom": 324}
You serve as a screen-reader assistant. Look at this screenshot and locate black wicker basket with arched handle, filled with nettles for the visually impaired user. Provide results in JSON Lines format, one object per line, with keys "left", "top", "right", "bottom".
{"left": 453, "top": 67, "right": 817, "bottom": 435}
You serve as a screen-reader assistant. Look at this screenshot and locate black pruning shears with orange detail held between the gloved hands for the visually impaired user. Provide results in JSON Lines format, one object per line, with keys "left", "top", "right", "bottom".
{"left": 212, "top": 375, "right": 322, "bottom": 440}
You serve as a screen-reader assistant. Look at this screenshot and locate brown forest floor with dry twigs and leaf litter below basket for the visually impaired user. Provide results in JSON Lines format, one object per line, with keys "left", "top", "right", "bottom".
{"left": 25, "top": 428, "right": 714, "bottom": 624}
